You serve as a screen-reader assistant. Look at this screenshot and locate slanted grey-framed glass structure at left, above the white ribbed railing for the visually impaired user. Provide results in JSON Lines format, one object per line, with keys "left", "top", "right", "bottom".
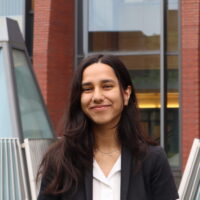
{"left": 0, "top": 18, "right": 54, "bottom": 140}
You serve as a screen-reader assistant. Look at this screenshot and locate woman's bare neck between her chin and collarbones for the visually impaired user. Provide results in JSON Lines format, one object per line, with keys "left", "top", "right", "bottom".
{"left": 93, "top": 123, "right": 121, "bottom": 152}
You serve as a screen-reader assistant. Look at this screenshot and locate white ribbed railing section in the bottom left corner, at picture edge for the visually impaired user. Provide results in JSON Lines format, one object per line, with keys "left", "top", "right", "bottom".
{"left": 0, "top": 138, "right": 28, "bottom": 200}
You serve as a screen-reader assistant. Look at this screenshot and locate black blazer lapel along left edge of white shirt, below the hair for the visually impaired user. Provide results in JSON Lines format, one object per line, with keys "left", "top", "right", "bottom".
{"left": 84, "top": 170, "right": 93, "bottom": 200}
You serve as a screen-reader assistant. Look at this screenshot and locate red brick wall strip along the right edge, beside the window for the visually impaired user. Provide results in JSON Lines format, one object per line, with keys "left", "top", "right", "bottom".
{"left": 181, "top": 0, "right": 200, "bottom": 169}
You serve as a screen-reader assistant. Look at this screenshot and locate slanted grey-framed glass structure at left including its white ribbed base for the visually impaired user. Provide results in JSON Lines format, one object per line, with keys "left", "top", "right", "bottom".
{"left": 0, "top": 18, "right": 55, "bottom": 200}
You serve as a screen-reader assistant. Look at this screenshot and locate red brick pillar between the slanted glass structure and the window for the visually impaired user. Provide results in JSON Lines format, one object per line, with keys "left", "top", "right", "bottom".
{"left": 33, "top": 0, "right": 75, "bottom": 134}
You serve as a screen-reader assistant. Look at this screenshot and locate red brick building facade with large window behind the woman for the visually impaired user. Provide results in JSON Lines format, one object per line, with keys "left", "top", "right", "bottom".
{"left": 31, "top": 0, "right": 200, "bottom": 171}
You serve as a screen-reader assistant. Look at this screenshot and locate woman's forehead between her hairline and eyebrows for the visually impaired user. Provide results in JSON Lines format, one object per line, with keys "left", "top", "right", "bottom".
{"left": 82, "top": 63, "right": 118, "bottom": 82}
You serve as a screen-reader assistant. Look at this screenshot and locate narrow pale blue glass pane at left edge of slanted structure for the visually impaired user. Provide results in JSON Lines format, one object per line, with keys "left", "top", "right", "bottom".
{"left": 0, "top": 48, "right": 14, "bottom": 138}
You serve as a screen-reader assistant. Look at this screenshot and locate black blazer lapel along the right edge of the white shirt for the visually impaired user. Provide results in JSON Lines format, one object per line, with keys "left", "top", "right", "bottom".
{"left": 121, "top": 147, "right": 132, "bottom": 200}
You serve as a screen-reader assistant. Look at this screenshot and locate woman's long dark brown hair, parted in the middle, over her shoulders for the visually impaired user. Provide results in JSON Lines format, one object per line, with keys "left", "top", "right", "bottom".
{"left": 38, "top": 55, "right": 153, "bottom": 194}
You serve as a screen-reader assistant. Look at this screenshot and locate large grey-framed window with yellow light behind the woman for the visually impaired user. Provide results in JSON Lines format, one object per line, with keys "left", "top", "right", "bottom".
{"left": 77, "top": 0, "right": 180, "bottom": 167}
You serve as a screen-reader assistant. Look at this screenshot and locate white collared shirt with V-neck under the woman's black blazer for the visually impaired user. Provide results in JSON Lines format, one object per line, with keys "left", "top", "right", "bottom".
{"left": 93, "top": 155, "right": 121, "bottom": 200}
